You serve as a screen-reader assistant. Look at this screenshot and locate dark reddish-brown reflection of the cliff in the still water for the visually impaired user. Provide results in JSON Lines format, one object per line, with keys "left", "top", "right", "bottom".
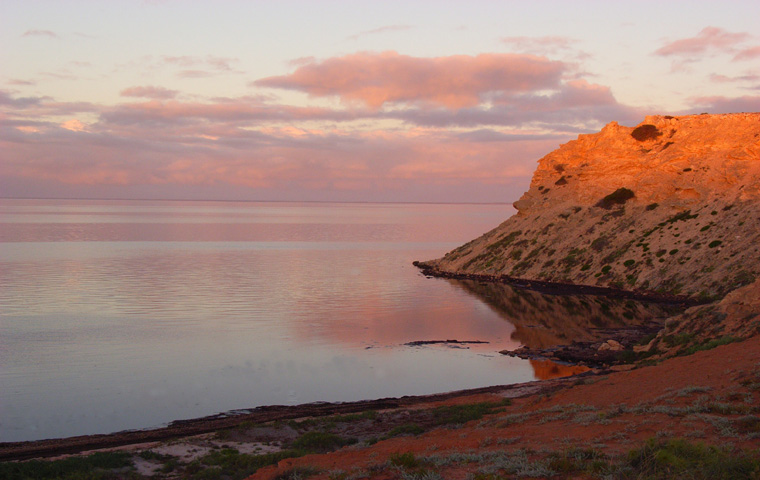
{"left": 452, "top": 280, "right": 677, "bottom": 348}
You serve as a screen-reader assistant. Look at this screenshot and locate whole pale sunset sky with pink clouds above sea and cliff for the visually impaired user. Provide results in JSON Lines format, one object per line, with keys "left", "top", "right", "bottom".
{"left": 0, "top": 0, "right": 760, "bottom": 203}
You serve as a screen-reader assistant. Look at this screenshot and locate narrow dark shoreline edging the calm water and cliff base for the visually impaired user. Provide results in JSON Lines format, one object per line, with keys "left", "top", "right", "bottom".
{"left": 0, "top": 276, "right": 684, "bottom": 461}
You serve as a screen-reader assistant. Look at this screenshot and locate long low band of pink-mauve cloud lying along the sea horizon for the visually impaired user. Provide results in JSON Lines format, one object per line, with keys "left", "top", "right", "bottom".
{"left": 0, "top": 109, "right": 560, "bottom": 200}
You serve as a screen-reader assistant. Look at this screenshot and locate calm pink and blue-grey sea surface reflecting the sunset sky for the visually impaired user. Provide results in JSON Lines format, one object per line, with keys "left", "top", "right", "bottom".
{"left": 0, "top": 199, "right": 535, "bottom": 441}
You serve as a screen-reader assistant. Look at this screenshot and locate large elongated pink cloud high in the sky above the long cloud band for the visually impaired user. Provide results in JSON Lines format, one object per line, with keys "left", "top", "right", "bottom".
{"left": 253, "top": 52, "right": 566, "bottom": 109}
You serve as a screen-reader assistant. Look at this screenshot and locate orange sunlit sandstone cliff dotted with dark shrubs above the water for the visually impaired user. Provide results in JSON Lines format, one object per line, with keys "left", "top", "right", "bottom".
{"left": 426, "top": 113, "right": 760, "bottom": 299}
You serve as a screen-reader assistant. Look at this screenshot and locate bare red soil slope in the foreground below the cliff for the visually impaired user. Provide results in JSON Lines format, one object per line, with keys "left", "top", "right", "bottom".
{"left": 250, "top": 336, "right": 760, "bottom": 480}
